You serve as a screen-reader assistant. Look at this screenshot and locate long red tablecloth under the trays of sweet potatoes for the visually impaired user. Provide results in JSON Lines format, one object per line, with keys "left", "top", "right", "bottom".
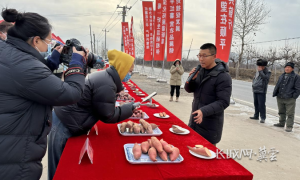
{"left": 54, "top": 80, "right": 253, "bottom": 180}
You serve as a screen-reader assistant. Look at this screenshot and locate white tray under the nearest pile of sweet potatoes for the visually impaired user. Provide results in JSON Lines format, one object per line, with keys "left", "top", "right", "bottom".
{"left": 124, "top": 144, "right": 184, "bottom": 164}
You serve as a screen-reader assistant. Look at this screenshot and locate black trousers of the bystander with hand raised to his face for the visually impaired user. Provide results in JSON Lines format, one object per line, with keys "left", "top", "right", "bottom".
{"left": 253, "top": 93, "right": 266, "bottom": 119}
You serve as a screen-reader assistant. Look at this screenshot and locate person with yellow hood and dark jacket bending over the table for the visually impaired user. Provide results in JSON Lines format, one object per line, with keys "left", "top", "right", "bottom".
{"left": 48, "top": 50, "right": 135, "bottom": 180}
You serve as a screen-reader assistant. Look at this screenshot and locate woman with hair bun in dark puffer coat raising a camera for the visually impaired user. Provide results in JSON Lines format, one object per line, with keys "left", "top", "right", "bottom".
{"left": 0, "top": 9, "right": 85, "bottom": 180}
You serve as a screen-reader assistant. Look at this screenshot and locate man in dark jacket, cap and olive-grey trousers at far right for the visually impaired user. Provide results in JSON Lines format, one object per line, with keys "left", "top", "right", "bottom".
{"left": 273, "top": 62, "right": 300, "bottom": 132}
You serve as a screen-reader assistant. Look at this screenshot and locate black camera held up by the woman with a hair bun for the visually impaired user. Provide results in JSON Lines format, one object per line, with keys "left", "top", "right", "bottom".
{"left": 59, "top": 38, "right": 97, "bottom": 68}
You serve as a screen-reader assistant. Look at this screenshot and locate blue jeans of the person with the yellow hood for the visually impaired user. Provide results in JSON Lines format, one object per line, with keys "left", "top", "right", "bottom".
{"left": 48, "top": 111, "right": 72, "bottom": 180}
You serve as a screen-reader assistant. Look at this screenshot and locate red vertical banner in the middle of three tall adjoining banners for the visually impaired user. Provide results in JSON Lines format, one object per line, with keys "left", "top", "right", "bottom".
{"left": 154, "top": 0, "right": 167, "bottom": 61}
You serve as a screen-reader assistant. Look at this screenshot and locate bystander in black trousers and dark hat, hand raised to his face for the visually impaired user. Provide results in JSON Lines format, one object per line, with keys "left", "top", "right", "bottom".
{"left": 250, "top": 59, "right": 271, "bottom": 123}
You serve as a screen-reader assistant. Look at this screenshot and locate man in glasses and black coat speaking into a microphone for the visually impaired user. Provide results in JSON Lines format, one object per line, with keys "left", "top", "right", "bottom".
{"left": 184, "top": 43, "right": 232, "bottom": 145}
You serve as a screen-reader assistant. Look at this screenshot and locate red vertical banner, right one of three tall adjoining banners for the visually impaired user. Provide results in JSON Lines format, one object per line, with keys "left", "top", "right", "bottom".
{"left": 167, "top": 0, "right": 183, "bottom": 61}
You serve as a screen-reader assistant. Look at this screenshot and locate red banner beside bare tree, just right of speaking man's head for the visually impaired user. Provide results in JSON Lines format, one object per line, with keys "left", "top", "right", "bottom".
{"left": 216, "top": 0, "right": 236, "bottom": 62}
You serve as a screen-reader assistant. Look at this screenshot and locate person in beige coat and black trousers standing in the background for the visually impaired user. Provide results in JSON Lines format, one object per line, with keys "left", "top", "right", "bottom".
{"left": 170, "top": 59, "right": 184, "bottom": 102}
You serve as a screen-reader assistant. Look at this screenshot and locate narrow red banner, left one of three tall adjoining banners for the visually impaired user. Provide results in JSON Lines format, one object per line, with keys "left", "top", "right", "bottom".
{"left": 143, "top": 1, "right": 153, "bottom": 61}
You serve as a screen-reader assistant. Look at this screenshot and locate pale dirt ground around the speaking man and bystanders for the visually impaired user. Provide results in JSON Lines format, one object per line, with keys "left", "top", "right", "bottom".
{"left": 131, "top": 74, "right": 300, "bottom": 180}
